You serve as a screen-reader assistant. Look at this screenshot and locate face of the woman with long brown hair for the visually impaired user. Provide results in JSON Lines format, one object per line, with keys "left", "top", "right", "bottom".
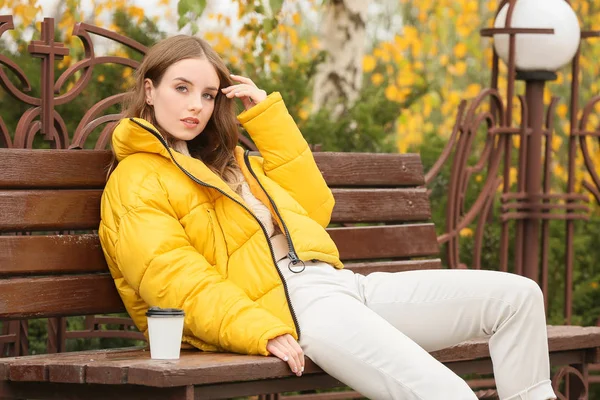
{"left": 144, "top": 58, "right": 220, "bottom": 141}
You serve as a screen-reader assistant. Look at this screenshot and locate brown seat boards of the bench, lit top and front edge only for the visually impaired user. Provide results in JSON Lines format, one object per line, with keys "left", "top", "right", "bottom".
{"left": 0, "top": 326, "right": 600, "bottom": 387}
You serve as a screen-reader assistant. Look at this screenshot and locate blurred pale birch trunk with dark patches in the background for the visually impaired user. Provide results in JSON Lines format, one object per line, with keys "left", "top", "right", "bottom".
{"left": 313, "top": 0, "right": 369, "bottom": 118}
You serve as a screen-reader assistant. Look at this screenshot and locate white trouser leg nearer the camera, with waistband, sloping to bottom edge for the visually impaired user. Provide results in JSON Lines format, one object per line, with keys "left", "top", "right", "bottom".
{"left": 280, "top": 260, "right": 476, "bottom": 400}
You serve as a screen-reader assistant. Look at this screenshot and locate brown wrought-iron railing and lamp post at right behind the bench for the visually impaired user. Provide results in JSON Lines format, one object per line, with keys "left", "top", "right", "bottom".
{"left": 426, "top": 0, "right": 600, "bottom": 398}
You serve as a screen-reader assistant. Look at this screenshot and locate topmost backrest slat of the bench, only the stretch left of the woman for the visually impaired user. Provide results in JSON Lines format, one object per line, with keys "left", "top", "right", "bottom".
{"left": 0, "top": 149, "right": 111, "bottom": 189}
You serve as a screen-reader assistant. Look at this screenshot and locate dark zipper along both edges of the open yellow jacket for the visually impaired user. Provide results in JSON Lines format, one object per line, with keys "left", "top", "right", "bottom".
{"left": 129, "top": 118, "right": 304, "bottom": 340}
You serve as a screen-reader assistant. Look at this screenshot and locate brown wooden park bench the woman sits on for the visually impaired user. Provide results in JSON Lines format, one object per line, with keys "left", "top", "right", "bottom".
{"left": 0, "top": 149, "right": 600, "bottom": 400}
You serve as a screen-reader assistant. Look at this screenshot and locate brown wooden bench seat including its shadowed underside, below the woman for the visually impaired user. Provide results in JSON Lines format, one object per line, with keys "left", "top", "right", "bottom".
{"left": 0, "top": 326, "right": 600, "bottom": 399}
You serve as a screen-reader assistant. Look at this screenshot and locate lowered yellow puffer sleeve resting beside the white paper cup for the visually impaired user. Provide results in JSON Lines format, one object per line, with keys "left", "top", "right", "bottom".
{"left": 116, "top": 203, "right": 293, "bottom": 355}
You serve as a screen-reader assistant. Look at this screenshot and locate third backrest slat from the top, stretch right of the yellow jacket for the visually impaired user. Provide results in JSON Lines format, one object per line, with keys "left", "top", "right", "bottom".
{"left": 327, "top": 224, "right": 439, "bottom": 260}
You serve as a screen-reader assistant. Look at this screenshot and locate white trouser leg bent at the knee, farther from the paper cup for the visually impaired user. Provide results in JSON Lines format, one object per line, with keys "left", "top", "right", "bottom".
{"left": 356, "top": 270, "right": 556, "bottom": 400}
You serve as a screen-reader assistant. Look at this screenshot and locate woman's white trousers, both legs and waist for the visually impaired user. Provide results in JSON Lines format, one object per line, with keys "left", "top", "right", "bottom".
{"left": 278, "top": 258, "right": 556, "bottom": 400}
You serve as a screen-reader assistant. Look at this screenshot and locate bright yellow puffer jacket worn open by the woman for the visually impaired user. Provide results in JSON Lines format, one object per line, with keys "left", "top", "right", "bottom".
{"left": 99, "top": 93, "right": 343, "bottom": 355}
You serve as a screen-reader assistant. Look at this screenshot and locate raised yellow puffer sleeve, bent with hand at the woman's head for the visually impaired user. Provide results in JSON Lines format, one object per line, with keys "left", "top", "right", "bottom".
{"left": 238, "top": 92, "right": 335, "bottom": 227}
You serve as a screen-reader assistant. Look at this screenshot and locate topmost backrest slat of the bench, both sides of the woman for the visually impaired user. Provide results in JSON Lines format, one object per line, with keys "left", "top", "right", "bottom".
{"left": 0, "top": 149, "right": 424, "bottom": 188}
